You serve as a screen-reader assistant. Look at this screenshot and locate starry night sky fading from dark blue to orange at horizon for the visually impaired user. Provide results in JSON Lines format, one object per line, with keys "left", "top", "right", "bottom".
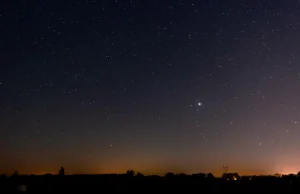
{"left": 0, "top": 0, "right": 300, "bottom": 175}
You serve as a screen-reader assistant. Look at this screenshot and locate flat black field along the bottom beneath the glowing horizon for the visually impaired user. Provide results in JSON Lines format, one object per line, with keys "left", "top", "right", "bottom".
{"left": 0, "top": 174, "right": 300, "bottom": 193}
